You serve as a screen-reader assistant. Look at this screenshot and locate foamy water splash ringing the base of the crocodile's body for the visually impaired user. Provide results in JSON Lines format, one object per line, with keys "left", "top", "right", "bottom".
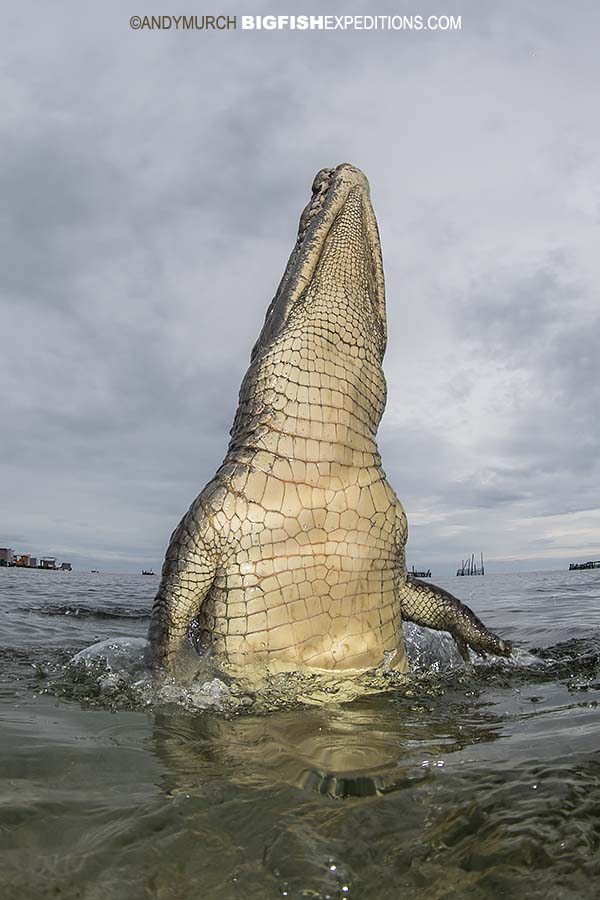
{"left": 56, "top": 623, "right": 539, "bottom": 715}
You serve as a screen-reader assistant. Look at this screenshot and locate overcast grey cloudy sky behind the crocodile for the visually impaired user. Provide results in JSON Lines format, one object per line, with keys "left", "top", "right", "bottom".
{"left": 0, "top": 0, "right": 600, "bottom": 574}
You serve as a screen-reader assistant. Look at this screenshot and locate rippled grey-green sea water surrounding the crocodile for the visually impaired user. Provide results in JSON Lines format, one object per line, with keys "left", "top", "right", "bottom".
{"left": 0, "top": 569, "right": 600, "bottom": 900}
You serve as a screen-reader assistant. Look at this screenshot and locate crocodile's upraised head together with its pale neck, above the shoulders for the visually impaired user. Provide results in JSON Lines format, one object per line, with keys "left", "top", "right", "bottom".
{"left": 228, "top": 165, "right": 386, "bottom": 467}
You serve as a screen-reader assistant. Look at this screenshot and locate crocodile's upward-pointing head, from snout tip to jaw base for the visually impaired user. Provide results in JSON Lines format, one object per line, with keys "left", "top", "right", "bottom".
{"left": 252, "top": 163, "right": 386, "bottom": 363}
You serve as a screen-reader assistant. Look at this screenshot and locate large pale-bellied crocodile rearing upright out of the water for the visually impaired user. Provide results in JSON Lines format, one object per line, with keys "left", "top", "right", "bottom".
{"left": 149, "top": 164, "right": 510, "bottom": 671}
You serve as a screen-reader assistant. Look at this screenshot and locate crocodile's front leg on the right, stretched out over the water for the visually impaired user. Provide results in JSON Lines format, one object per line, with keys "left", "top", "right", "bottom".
{"left": 399, "top": 576, "right": 512, "bottom": 660}
